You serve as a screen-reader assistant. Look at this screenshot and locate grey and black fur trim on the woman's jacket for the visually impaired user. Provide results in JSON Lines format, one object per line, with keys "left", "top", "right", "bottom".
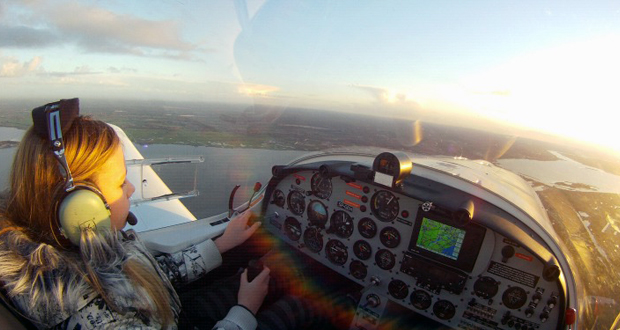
{"left": 0, "top": 230, "right": 180, "bottom": 328}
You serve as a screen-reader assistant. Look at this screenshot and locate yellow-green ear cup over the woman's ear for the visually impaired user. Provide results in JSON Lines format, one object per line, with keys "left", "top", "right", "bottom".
{"left": 58, "top": 186, "right": 111, "bottom": 246}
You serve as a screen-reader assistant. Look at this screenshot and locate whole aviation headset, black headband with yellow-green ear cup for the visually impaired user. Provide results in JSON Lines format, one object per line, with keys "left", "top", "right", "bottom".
{"left": 32, "top": 98, "right": 111, "bottom": 246}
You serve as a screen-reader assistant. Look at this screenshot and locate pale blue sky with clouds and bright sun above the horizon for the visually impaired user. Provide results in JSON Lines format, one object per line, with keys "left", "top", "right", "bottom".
{"left": 0, "top": 0, "right": 620, "bottom": 151}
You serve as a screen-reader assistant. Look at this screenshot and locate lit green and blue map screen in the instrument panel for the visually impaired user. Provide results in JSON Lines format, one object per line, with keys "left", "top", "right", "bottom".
{"left": 416, "top": 217, "right": 465, "bottom": 260}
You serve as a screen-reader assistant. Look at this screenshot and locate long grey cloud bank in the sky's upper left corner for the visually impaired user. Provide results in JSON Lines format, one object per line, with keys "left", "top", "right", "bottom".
{"left": 0, "top": 1, "right": 206, "bottom": 60}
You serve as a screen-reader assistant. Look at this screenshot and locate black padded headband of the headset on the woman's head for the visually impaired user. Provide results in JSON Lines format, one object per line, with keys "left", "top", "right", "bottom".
{"left": 32, "top": 98, "right": 80, "bottom": 191}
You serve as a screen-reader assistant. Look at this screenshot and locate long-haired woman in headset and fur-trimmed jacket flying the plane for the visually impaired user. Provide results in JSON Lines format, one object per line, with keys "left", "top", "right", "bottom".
{"left": 0, "top": 99, "right": 320, "bottom": 330}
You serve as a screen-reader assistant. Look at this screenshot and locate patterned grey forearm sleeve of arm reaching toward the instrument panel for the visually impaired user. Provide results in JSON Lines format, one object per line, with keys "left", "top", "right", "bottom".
{"left": 155, "top": 239, "right": 222, "bottom": 287}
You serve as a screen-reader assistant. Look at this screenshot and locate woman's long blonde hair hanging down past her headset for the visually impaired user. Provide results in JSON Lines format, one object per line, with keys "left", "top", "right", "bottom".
{"left": 0, "top": 116, "right": 174, "bottom": 326}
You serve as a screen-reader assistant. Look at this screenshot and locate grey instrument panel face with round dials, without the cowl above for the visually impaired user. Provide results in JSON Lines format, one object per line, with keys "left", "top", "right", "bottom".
{"left": 264, "top": 157, "right": 564, "bottom": 330}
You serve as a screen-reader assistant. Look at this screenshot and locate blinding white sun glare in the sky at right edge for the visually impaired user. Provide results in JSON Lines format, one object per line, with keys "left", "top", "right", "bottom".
{"left": 453, "top": 36, "right": 620, "bottom": 152}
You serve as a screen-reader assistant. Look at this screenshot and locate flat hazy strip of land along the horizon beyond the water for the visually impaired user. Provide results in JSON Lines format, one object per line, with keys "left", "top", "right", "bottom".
{"left": 0, "top": 100, "right": 620, "bottom": 171}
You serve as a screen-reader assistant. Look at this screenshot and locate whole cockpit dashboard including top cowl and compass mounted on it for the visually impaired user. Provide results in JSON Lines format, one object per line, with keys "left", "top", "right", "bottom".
{"left": 262, "top": 152, "right": 571, "bottom": 330}
